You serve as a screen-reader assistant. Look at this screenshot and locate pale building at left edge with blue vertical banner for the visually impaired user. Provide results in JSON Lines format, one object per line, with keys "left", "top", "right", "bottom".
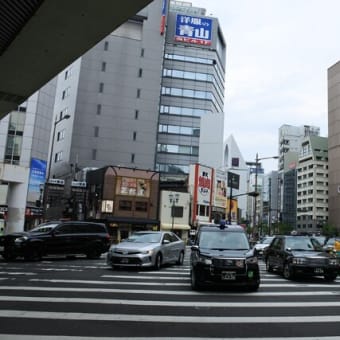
{"left": 0, "top": 79, "right": 56, "bottom": 232}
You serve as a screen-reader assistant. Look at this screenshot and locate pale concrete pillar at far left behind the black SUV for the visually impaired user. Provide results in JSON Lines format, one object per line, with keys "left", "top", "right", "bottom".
{"left": 6, "top": 183, "right": 27, "bottom": 234}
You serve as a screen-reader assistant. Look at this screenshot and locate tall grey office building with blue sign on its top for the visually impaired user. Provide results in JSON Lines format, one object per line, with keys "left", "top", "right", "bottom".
{"left": 50, "top": 0, "right": 226, "bottom": 180}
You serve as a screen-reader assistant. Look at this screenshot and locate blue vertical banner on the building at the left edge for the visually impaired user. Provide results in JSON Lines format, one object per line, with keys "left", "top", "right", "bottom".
{"left": 27, "top": 158, "right": 46, "bottom": 202}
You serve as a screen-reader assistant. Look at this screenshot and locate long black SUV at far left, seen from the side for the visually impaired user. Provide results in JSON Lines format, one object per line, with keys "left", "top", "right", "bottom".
{"left": 0, "top": 221, "right": 110, "bottom": 260}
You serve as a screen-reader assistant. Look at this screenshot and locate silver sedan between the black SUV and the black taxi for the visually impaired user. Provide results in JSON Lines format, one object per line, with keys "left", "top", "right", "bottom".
{"left": 107, "top": 231, "right": 185, "bottom": 269}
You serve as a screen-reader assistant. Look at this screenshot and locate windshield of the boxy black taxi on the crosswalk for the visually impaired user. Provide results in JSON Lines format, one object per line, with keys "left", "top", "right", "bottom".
{"left": 199, "top": 231, "right": 249, "bottom": 250}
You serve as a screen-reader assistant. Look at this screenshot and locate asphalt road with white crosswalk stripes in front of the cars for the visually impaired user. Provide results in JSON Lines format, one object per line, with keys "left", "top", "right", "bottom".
{"left": 0, "top": 250, "right": 340, "bottom": 340}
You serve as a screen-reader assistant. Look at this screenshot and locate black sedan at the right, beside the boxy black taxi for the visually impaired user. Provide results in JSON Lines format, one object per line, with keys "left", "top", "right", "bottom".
{"left": 265, "top": 235, "right": 339, "bottom": 281}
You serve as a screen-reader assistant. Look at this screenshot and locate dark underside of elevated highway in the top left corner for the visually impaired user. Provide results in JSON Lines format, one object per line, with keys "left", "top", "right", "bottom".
{"left": 0, "top": 0, "right": 153, "bottom": 119}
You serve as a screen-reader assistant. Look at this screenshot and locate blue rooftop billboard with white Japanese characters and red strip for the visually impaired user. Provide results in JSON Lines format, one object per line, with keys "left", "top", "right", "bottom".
{"left": 175, "top": 14, "right": 212, "bottom": 46}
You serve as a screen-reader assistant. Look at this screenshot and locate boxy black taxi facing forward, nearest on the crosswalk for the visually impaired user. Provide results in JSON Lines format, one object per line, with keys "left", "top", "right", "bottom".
{"left": 190, "top": 221, "right": 260, "bottom": 291}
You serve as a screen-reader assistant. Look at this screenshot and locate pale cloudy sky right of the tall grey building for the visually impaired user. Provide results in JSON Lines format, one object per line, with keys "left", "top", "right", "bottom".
{"left": 191, "top": 0, "right": 340, "bottom": 172}
